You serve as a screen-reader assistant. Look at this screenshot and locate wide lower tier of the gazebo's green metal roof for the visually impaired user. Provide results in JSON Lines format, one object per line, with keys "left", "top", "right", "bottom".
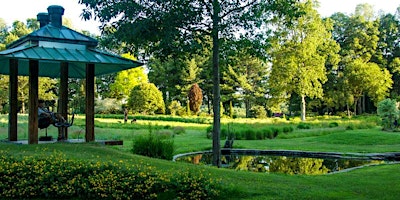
{"left": 0, "top": 45, "right": 143, "bottom": 78}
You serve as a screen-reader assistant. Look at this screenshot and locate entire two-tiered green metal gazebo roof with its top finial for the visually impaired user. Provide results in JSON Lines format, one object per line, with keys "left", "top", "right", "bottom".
{"left": 0, "top": 6, "right": 143, "bottom": 78}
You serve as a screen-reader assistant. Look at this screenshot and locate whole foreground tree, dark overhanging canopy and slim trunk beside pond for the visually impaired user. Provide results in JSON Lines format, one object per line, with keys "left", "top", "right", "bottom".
{"left": 79, "top": 0, "right": 297, "bottom": 166}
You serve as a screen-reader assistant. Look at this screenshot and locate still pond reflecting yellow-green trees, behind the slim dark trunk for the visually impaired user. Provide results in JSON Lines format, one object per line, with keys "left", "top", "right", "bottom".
{"left": 174, "top": 149, "right": 399, "bottom": 175}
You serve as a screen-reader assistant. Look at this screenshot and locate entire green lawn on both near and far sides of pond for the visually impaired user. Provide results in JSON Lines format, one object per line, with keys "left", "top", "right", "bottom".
{"left": 0, "top": 115, "right": 400, "bottom": 200}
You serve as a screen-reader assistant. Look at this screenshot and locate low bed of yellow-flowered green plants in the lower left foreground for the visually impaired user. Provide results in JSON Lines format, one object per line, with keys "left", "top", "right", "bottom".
{"left": 0, "top": 151, "right": 219, "bottom": 199}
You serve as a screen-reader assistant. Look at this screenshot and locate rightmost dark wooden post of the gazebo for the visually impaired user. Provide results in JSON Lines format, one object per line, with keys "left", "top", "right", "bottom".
{"left": 85, "top": 64, "right": 95, "bottom": 142}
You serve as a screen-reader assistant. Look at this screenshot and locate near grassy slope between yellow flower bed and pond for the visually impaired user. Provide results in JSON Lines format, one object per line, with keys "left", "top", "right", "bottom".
{"left": 0, "top": 143, "right": 400, "bottom": 199}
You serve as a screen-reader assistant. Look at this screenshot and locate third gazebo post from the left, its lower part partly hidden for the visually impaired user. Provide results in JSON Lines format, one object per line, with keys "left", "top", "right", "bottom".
{"left": 57, "top": 62, "right": 68, "bottom": 140}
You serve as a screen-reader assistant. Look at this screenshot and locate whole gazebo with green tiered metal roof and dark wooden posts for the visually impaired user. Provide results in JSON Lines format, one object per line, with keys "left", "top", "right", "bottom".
{"left": 0, "top": 5, "right": 143, "bottom": 144}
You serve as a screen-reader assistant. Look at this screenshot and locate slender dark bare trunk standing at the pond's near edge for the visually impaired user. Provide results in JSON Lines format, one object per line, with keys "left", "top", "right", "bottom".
{"left": 212, "top": 0, "right": 221, "bottom": 167}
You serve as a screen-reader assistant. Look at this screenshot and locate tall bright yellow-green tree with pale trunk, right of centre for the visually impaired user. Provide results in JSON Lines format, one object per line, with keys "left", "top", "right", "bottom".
{"left": 269, "top": 1, "right": 339, "bottom": 121}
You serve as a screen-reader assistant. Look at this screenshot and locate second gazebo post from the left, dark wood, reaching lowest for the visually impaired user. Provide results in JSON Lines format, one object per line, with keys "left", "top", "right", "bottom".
{"left": 28, "top": 60, "right": 39, "bottom": 144}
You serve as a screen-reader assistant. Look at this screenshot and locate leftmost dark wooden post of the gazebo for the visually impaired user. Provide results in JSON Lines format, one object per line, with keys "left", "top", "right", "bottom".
{"left": 8, "top": 59, "right": 18, "bottom": 141}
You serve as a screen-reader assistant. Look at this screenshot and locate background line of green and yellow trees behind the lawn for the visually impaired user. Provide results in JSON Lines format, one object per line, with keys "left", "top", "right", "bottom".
{"left": 0, "top": 1, "right": 400, "bottom": 120}
